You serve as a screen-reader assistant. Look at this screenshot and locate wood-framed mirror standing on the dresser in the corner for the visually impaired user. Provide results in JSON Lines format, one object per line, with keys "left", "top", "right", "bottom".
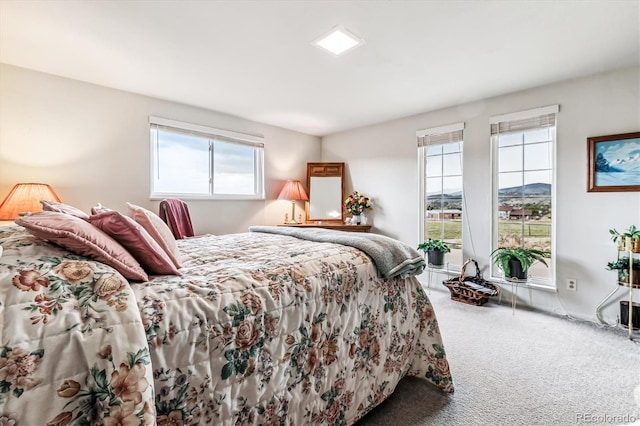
{"left": 305, "top": 163, "right": 344, "bottom": 224}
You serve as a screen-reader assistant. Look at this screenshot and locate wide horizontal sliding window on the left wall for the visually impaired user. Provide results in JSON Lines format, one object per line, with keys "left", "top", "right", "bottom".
{"left": 150, "top": 117, "right": 264, "bottom": 199}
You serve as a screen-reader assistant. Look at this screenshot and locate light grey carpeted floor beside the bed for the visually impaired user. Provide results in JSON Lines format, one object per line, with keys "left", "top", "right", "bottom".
{"left": 357, "top": 288, "right": 640, "bottom": 426}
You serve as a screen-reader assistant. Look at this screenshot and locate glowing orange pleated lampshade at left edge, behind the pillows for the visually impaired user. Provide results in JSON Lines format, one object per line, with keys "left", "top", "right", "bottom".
{"left": 0, "top": 183, "right": 60, "bottom": 220}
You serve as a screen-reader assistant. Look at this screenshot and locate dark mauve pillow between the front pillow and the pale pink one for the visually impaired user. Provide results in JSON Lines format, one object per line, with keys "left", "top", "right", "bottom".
{"left": 89, "top": 210, "right": 180, "bottom": 275}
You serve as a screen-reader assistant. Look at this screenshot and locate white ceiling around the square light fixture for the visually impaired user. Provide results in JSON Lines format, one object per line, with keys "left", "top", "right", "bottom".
{"left": 0, "top": 0, "right": 640, "bottom": 136}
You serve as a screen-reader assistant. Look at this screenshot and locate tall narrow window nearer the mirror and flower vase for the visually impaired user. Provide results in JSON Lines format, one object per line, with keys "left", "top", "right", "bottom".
{"left": 416, "top": 123, "right": 464, "bottom": 267}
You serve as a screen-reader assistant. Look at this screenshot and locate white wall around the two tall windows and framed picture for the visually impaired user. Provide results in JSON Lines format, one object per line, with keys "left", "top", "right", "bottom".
{"left": 322, "top": 67, "right": 640, "bottom": 322}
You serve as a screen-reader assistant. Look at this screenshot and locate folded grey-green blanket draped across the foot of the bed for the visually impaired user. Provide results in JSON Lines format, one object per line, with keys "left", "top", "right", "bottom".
{"left": 249, "top": 226, "right": 427, "bottom": 278}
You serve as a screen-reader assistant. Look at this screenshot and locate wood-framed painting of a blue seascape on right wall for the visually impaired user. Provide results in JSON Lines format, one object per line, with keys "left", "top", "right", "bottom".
{"left": 587, "top": 132, "right": 640, "bottom": 192}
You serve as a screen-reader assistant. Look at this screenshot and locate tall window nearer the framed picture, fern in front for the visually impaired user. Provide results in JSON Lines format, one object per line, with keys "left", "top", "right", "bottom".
{"left": 491, "top": 105, "right": 558, "bottom": 286}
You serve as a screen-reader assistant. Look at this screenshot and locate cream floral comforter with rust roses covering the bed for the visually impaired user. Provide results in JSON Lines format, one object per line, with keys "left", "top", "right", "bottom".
{"left": 0, "top": 226, "right": 453, "bottom": 425}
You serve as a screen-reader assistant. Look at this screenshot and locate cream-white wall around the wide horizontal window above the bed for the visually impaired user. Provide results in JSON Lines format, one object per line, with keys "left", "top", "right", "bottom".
{"left": 0, "top": 64, "right": 320, "bottom": 234}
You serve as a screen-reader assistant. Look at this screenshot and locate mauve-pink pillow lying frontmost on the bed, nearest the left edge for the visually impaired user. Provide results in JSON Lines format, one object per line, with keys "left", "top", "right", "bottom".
{"left": 15, "top": 211, "right": 149, "bottom": 281}
